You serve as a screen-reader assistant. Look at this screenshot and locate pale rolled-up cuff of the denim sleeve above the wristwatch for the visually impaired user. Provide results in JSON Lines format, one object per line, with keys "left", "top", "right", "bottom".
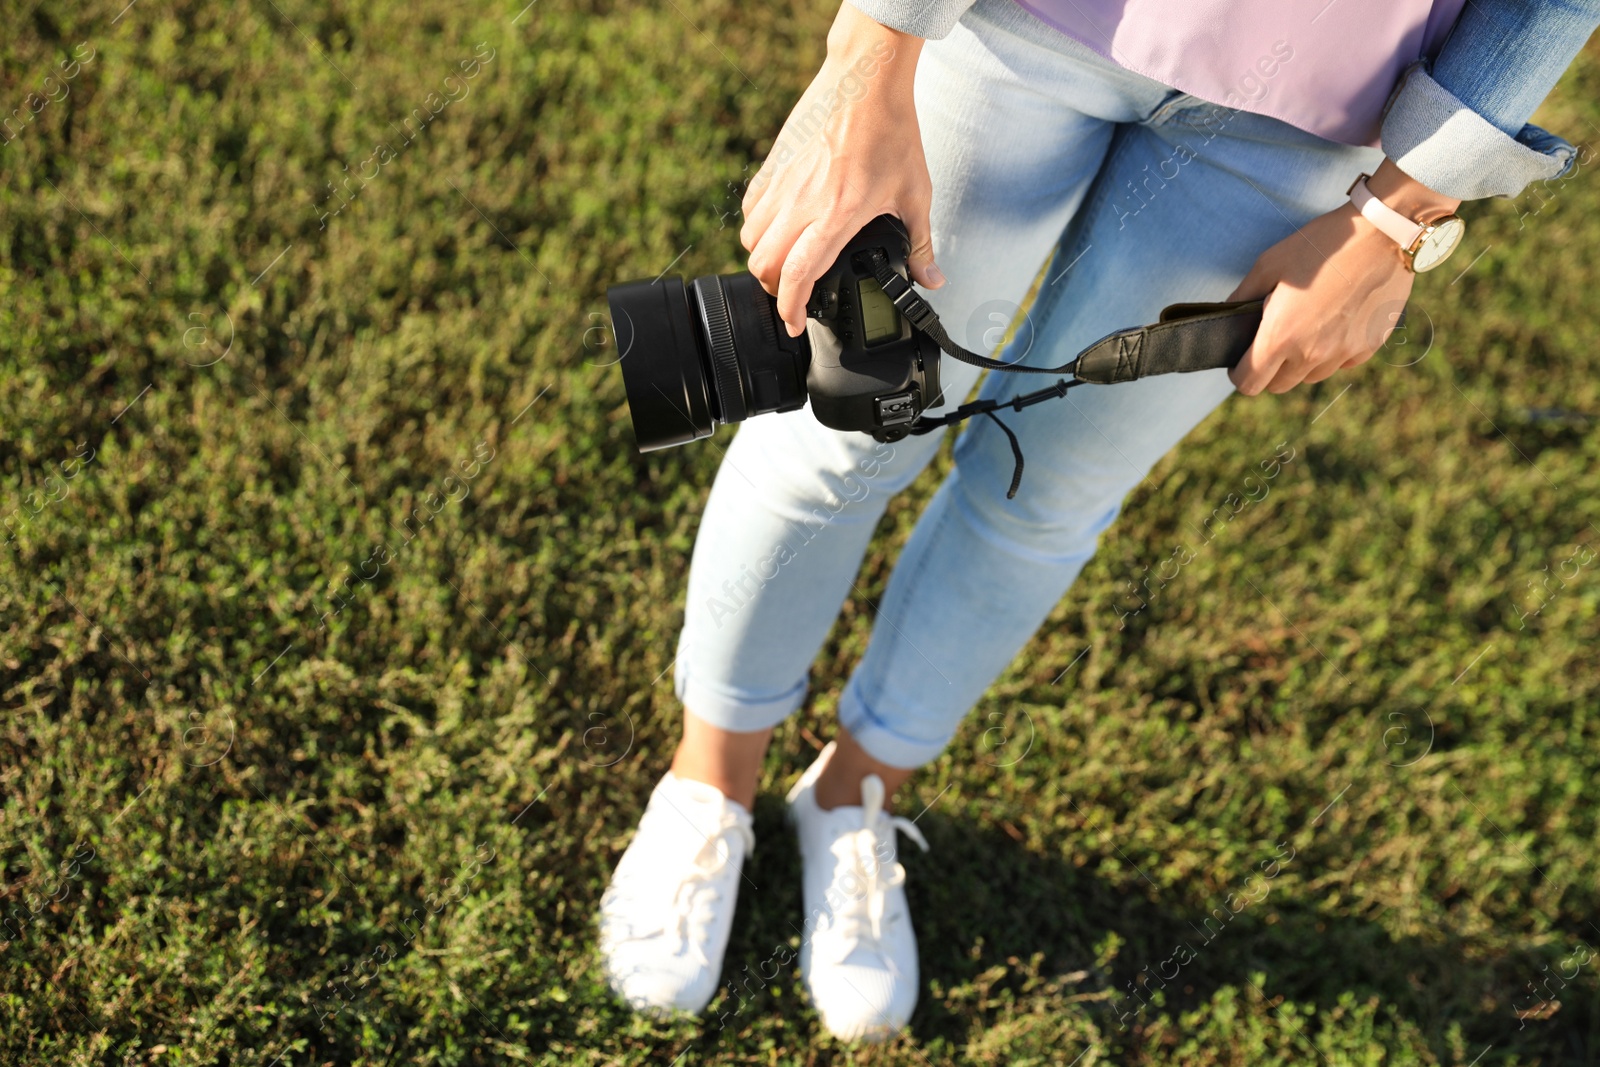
{"left": 1382, "top": 64, "right": 1578, "bottom": 200}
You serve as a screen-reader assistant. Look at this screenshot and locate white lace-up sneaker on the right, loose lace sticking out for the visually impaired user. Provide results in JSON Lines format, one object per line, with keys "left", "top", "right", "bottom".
{"left": 789, "top": 744, "right": 928, "bottom": 1041}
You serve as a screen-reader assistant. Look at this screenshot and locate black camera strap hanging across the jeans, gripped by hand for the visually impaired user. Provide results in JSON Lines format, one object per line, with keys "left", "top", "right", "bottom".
{"left": 867, "top": 248, "right": 1260, "bottom": 499}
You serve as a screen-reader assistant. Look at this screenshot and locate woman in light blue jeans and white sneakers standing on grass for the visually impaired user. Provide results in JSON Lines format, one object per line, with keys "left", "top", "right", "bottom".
{"left": 600, "top": 0, "right": 1600, "bottom": 1038}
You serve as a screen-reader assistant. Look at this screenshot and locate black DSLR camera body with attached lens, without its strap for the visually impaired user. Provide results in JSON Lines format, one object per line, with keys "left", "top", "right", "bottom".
{"left": 606, "top": 214, "right": 942, "bottom": 453}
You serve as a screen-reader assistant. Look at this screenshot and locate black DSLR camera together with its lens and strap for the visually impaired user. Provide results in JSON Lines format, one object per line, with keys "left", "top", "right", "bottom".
{"left": 606, "top": 214, "right": 1273, "bottom": 499}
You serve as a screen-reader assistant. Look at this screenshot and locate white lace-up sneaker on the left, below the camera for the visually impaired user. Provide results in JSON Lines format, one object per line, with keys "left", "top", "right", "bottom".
{"left": 600, "top": 771, "right": 755, "bottom": 1014}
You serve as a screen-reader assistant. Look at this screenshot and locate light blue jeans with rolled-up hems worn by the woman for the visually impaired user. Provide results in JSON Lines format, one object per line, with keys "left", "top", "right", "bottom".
{"left": 675, "top": 0, "right": 1382, "bottom": 768}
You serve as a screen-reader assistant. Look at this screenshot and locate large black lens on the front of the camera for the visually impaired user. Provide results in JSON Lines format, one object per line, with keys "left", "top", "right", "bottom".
{"left": 606, "top": 272, "right": 811, "bottom": 451}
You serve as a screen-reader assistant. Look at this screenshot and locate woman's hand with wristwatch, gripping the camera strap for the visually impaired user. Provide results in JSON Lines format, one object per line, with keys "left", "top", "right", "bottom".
{"left": 1227, "top": 160, "right": 1461, "bottom": 397}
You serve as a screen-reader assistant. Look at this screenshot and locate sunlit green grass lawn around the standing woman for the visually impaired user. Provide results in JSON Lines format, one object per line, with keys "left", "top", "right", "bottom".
{"left": 0, "top": 0, "right": 1600, "bottom": 1067}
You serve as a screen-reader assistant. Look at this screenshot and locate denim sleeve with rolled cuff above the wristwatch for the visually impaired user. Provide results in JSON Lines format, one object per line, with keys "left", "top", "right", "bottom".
{"left": 1382, "top": 0, "right": 1600, "bottom": 200}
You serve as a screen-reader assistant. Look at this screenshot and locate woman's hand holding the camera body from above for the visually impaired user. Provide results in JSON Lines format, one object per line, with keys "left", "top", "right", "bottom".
{"left": 739, "top": 3, "right": 944, "bottom": 338}
